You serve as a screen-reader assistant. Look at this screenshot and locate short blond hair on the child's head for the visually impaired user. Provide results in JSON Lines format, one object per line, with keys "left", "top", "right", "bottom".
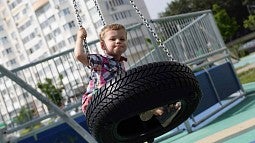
{"left": 99, "top": 24, "right": 127, "bottom": 41}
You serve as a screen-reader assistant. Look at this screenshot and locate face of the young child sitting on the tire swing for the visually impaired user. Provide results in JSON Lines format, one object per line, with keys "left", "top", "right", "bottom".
{"left": 101, "top": 29, "right": 127, "bottom": 60}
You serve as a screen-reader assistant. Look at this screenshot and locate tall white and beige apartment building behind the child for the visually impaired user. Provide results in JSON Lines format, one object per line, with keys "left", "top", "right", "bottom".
{"left": 0, "top": 0, "right": 149, "bottom": 125}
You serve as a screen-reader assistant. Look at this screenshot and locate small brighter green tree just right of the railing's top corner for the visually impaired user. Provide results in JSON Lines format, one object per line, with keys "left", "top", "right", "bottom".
{"left": 213, "top": 4, "right": 239, "bottom": 41}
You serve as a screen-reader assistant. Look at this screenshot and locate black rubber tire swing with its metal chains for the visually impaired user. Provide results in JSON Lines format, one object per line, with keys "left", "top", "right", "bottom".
{"left": 74, "top": 0, "right": 201, "bottom": 143}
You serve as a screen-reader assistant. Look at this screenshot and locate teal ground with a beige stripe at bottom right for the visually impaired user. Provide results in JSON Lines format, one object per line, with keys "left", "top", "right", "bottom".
{"left": 155, "top": 83, "right": 255, "bottom": 143}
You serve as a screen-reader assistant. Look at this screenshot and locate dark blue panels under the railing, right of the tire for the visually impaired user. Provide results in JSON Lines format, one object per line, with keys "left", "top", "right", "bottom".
{"left": 194, "top": 62, "right": 241, "bottom": 115}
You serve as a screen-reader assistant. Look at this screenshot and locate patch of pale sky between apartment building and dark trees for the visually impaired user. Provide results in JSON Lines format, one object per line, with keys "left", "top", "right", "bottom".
{"left": 144, "top": 0, "right": 173, "bottom": 19}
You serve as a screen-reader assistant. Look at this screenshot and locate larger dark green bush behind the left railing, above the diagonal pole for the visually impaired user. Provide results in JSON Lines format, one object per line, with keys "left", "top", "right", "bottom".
{"left": 37, "top": 75, "right": 64, "bottom": 107}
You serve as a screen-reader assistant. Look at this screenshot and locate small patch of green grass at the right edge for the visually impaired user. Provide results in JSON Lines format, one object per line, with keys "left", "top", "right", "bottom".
{"left": 237, "top": 68, "right": 255, "bottom": 84}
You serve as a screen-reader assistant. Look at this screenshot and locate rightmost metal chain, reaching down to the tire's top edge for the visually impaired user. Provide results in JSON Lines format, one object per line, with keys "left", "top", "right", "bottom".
{"left": 129, "top": 0, "right": 175, "bottom": 61}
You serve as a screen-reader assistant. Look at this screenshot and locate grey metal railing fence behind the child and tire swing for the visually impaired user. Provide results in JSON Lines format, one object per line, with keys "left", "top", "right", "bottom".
{"left": 0, "top": 11, "right": 229, "bottom": 142}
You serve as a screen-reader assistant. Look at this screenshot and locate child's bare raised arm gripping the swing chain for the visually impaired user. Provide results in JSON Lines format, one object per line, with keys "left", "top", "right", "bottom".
{"left": 74, "top": 27, "right": 89, "bottom": 66}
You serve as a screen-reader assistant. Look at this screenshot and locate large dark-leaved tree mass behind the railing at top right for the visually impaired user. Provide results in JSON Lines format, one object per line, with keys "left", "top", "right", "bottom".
{"left": 160, "top": 0, "right": 250, "bottom": 39}
